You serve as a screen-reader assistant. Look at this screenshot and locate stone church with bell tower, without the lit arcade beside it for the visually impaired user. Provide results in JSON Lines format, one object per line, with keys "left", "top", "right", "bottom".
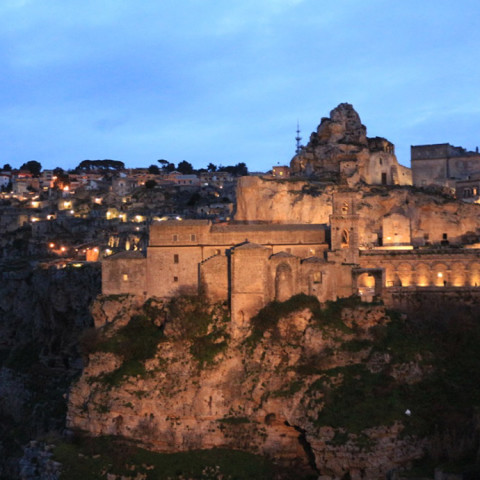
{"left": 102, "top": 195, "right": 382, "bottom": 321}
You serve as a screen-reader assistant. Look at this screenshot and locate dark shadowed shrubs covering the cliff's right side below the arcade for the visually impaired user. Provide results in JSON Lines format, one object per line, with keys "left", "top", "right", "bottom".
{"left": 304, "top": 304, "right": 480, "bottom": 462}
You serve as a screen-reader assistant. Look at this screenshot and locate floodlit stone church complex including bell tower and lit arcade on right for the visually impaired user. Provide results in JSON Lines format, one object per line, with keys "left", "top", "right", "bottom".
{"left": 102, "top": 183, "right": 480, "bottom": 325}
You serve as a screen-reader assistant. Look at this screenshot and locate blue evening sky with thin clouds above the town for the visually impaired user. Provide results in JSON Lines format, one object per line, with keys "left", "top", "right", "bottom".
{"left": 0, "top": 0, "right": 480, "bottom": 171}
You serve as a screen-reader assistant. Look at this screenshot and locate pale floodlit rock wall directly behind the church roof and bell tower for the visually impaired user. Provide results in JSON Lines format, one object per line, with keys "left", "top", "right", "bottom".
{"left": 235, "top": 177, "right": 480, "bottom": 246}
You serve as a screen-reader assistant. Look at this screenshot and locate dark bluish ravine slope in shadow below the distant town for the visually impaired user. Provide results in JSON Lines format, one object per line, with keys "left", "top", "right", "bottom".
{"left": 0, "top": 260, "right": 100, "bottom": 478}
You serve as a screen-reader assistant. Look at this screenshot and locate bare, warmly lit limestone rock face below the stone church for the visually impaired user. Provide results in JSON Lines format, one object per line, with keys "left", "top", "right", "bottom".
{"left": 67, "top": 299, "right": 423, "bottom": 480}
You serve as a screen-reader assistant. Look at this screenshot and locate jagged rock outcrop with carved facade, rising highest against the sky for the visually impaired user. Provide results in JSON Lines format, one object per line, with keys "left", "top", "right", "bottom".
{"left": 290, "top": 103, "right": 412, "bottom": 186}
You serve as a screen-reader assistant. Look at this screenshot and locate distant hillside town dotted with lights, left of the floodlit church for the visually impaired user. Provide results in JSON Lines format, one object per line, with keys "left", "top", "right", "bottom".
{"left": 0, "top": 160, "right": 247, "bottom": 268}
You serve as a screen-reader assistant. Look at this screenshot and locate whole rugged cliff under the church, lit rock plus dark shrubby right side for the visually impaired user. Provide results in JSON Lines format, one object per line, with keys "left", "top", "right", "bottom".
{"left": 68, "top": 296, "right": 480, "bottom": 480}
